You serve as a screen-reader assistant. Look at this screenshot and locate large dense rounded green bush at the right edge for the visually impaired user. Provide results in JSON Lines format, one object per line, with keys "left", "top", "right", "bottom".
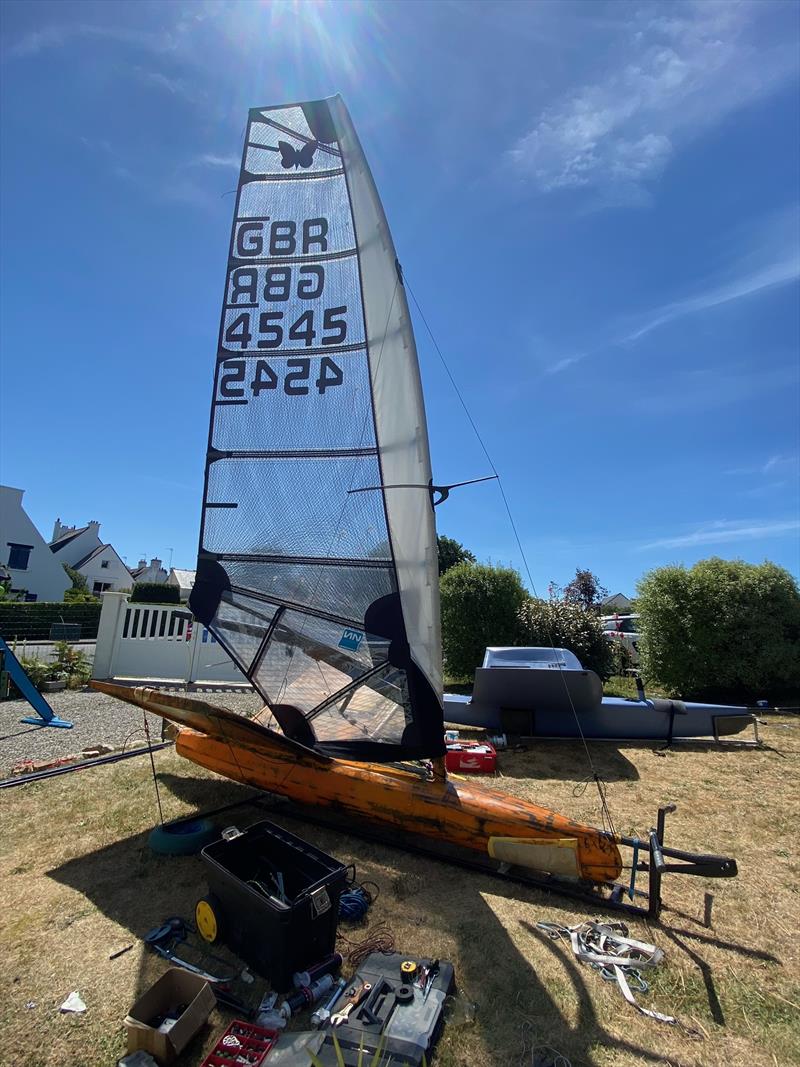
{"left": 637, "top": 558, "right": 800, "bottom": 701}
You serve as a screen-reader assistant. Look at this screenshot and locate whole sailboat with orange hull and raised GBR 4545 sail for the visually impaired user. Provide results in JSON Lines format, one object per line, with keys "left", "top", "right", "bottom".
{"left": 93, "top": 96, "right": 736, "bottom": 903}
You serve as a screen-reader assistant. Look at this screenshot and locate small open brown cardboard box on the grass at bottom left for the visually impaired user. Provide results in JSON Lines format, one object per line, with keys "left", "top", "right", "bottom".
{"left": 125, "top": 967, "right": 217, "bottom": 1064}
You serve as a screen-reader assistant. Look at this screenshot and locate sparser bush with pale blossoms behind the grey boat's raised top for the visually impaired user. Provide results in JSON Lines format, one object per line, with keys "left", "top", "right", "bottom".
{"left": 516, "top": 600, "right": 614, "bottom": 682}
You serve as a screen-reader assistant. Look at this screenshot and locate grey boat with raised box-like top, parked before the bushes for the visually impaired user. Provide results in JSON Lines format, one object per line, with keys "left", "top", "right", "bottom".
{"left": 445, "top": 667, "right": 755, "bottom": 740}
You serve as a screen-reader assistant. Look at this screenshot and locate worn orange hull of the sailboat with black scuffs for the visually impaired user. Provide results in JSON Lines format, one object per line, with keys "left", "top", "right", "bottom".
{"left": 93, "top": 683, "right": 622, "bottom": 882}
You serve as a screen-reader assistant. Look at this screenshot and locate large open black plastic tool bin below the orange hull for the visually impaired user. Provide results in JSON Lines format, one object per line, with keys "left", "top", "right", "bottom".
{"left": 201, "top": 821, "right": 346, "bottom": 992}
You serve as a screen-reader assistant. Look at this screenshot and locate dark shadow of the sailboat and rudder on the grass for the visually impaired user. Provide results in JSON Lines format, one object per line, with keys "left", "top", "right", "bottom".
{"left": 48, "top": 774, "right": 774, "bottom": 1064}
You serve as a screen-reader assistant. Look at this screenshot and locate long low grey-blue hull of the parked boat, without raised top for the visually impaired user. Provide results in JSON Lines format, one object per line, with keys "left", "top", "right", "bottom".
{"left": 445, "top": 695, "right": 754, "bottom": 740}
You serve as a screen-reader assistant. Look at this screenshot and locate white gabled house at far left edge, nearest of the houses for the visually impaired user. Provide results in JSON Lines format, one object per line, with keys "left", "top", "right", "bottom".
{"left": 0, "top": 485, "right": 73, "bottom": 602}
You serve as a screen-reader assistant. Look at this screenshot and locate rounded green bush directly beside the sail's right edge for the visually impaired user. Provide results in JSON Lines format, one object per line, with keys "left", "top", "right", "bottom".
{"left": 441, "top": 562, "right": 528, "bottom": 679}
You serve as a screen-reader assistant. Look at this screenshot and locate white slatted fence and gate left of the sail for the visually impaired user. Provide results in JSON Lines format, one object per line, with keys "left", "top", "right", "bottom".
{"left": 92, "top": 592, "right": 250, "bottom": 686}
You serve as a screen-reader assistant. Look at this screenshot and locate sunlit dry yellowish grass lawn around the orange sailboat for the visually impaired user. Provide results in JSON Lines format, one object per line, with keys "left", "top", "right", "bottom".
{"left": 0, "top": 718, "right": 800, "bottom": 1067}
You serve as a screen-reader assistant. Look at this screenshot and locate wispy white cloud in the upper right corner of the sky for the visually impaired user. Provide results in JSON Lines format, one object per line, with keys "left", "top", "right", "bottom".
{"left": 509, "top": 2, "right": 798, "bottom": 202}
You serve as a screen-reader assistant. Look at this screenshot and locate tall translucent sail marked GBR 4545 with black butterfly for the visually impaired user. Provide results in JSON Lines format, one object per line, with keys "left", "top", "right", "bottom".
{"left": 190, "top": 97, "right": 444, "bottom": 761}
